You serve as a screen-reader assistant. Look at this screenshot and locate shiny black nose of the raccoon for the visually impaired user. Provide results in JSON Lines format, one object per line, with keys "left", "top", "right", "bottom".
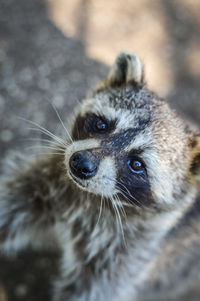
{"left": 69, "top": 151, "right": 98, "bottom": 179}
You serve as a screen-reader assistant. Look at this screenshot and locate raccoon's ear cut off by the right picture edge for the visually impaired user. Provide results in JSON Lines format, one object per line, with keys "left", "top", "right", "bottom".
{"left": 190, "top": 134, "right": 200, "bottom": 180}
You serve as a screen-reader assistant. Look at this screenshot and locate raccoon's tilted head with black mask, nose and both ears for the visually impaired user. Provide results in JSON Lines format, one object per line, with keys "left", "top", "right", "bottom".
{"left": 65, "top": 53, "right": 200, "bottom": 208}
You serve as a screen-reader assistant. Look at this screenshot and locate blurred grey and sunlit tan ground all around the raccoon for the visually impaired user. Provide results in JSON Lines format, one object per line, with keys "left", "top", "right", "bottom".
{"left": 0, "top": 0, "right": 200, "bottom": 301}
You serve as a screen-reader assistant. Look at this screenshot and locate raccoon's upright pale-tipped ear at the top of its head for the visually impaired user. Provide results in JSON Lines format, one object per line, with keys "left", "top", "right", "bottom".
{"left": 106, "top": 52, "right": 143, "bottom": 86}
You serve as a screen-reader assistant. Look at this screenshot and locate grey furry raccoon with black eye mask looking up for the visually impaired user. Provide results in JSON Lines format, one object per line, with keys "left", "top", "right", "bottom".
{"left": 0, "top": 52, "right": 200, "bottom": 301}
